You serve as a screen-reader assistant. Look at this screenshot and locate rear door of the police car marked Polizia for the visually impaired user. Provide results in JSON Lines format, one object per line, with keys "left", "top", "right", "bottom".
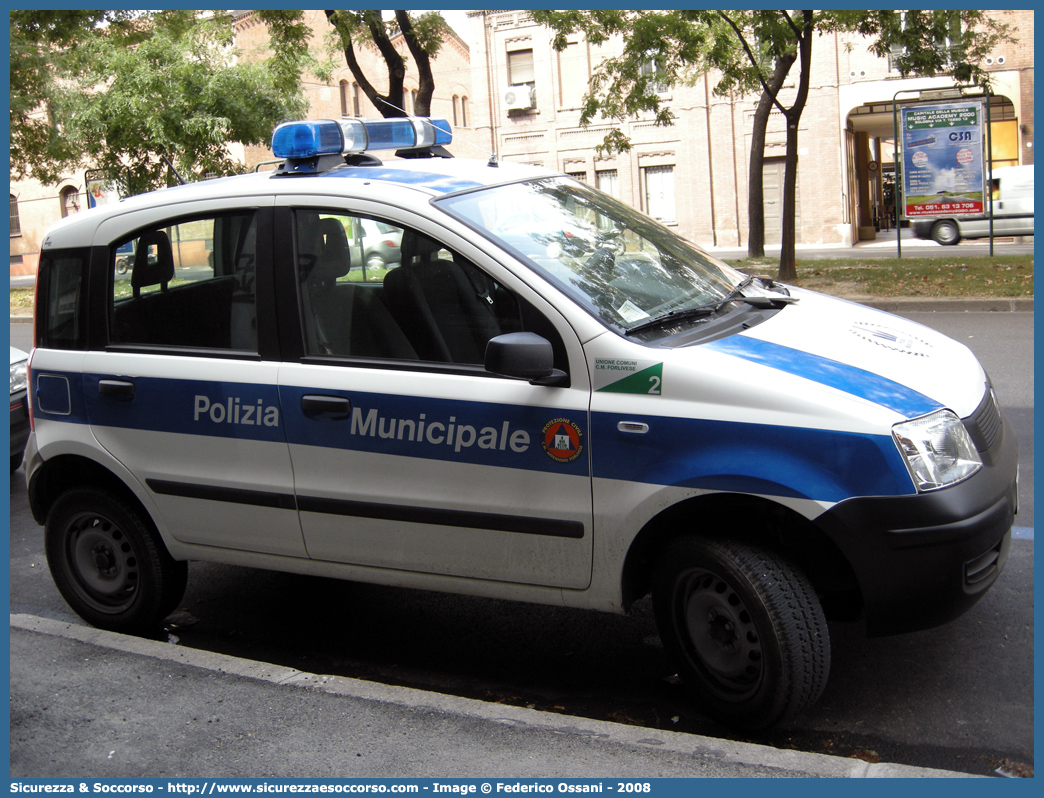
{"left": 84, "top": 197, "right": 305, "bottom": 557}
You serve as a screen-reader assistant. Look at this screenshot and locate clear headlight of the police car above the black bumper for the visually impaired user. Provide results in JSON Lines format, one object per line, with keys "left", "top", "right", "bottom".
{"left": 892, "top": 410, "right": 982, "bottom": 491}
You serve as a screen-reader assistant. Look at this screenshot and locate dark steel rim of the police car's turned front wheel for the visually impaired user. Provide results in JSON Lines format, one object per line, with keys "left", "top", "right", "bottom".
{"left": 675, "top": 568, "right": 764, "bottom": 701}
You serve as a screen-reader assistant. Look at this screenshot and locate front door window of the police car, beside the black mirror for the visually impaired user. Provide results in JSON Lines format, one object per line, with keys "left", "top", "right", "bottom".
{"left": 294, "top": 209, "right": 520, "bottom": 366}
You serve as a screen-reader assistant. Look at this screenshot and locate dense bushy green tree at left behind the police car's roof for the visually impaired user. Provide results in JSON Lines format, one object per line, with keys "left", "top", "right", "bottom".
{"left": 10, "top": 10, "right": 309, "bottom": 193}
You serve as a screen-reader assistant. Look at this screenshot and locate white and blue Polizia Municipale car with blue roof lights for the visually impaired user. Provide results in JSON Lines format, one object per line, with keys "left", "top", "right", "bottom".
{"left": 25, "top": 118, "right": 1018, "bottom": 728}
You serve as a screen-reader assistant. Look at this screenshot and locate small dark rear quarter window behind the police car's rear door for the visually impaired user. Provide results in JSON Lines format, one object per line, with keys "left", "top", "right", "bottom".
{"left": 37, "top": 249, "right": 90, "bottom": 349}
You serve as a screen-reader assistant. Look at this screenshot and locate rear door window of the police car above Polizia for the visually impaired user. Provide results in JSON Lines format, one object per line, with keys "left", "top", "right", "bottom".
{"left": 109, "top": 211, "right": 258, "bottom": 352}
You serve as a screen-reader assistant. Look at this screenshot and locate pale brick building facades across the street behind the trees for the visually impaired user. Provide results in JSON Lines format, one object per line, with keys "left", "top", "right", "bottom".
{"left": 10, "top": 10, "right": 1034, "bottom": 275}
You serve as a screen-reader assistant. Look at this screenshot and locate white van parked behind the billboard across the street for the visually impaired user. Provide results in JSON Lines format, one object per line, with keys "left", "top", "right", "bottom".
{"left": 910, "top": 164, "right": 1034, "bottom": 244}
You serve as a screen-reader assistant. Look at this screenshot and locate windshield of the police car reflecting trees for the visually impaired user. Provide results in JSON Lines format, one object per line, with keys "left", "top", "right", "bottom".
{"left": 438, "top": 178, "right": 744, "bottom": 332}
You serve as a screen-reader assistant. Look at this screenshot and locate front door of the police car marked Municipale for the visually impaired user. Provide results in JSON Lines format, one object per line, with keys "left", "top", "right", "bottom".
{"left": 277, "top": 197, "right": 592, "bottom": 588}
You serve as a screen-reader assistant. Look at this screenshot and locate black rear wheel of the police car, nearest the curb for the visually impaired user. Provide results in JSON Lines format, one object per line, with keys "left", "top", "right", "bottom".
{"left": 44, "top": 488, "right": 188, "bottom": 634}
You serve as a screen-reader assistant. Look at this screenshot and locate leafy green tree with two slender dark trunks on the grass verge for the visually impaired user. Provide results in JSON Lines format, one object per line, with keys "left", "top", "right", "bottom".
{"left": 533, "top": 9, "right": 1011, "bottom": 279}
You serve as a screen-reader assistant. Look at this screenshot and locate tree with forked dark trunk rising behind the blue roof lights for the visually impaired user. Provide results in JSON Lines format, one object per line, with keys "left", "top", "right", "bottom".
{"left": 326, "top": 10, "right": 449, "bottom": 117}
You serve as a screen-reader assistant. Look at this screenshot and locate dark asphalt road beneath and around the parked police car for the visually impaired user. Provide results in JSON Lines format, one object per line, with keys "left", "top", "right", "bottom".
{"left": 10, "top": 313, "right": 1034, "bottom": 774}
